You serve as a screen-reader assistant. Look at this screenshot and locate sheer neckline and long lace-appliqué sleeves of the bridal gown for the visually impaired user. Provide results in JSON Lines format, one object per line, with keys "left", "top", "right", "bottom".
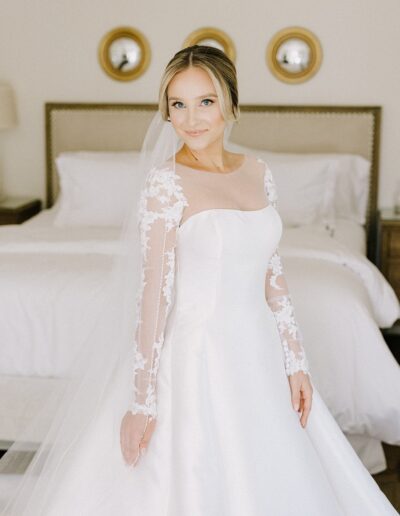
{"left": 130, "top": 156, "right": 309, "bottom": 418}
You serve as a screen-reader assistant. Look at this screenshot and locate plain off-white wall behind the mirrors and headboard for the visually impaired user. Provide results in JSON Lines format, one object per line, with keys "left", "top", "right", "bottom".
{"left": 0, "top": 0, "right": 400, "bottom": 207}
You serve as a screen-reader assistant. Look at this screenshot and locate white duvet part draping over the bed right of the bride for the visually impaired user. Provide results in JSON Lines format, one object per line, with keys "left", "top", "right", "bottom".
{"left": 280, "top": 227, "right": 400, "bottom": 444}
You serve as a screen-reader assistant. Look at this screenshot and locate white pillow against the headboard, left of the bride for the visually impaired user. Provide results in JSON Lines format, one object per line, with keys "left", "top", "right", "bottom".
{"left": 54, "top": 151, "right": 141, "bottom": 226}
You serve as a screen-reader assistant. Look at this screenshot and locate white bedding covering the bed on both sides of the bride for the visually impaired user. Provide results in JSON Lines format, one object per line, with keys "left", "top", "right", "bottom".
{"left": 0, "top": 208, "right": 400, "bottom": 472}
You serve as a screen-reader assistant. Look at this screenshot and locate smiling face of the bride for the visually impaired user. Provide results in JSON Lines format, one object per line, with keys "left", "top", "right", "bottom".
{"left": 167, "top": 67, "right": 226, "bottom": 151}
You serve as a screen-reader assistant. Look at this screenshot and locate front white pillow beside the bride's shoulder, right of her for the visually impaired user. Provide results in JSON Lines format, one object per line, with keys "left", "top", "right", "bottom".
{"left": 227, "top": 142, "right": 336, "bottom": 228}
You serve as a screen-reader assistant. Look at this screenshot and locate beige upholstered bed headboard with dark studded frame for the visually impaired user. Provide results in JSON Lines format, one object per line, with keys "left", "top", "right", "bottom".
{"left": 45, "top": 102, "right": 381, "bottom": 260}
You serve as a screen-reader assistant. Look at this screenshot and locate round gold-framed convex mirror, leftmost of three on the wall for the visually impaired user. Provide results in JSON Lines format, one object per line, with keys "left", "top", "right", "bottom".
{"left": 99, "top": 27, "right": 151, "bottom": 81}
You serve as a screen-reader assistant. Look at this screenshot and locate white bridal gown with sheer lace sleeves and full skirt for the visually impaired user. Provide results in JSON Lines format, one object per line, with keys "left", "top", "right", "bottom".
{"left": 3, "top": 156, "right": 397, "bottom": 516}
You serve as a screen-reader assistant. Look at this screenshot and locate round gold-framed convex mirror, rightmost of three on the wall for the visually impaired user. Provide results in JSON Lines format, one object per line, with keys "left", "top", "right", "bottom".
{"left": 267, "top": 27, "right": 322, "bottom": 84}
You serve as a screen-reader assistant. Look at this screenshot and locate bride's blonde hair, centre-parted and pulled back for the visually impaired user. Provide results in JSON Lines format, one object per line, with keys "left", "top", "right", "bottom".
{"left": 158, "top": 45, "right": 240, "bottom": 121}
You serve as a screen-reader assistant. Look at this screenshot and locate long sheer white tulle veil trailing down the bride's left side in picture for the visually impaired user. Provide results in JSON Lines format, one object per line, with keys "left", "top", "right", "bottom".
{"left": 0, "top": 111, "right": 232, "bottom": 516}
